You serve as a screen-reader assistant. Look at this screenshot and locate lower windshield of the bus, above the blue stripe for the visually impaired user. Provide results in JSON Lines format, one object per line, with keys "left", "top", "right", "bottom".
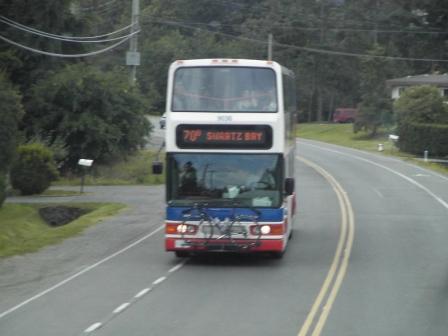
{"left": 167, "top": 153, "right": 283, "bottom": 207}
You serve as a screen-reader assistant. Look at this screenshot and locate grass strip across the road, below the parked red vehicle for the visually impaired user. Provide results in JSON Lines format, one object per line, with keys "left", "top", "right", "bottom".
{"left": 297, "top": 123, "right": 448, "bottom": 174}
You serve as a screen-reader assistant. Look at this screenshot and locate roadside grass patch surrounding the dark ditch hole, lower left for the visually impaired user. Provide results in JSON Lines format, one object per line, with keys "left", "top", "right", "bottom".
{"left": 0, "top": 203, "right": 126, "bottom": 258}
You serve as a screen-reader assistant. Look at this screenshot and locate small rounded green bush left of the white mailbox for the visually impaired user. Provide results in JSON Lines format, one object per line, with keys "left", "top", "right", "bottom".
{"left": 10, "top": 143, "right": 58, "bottom": 195}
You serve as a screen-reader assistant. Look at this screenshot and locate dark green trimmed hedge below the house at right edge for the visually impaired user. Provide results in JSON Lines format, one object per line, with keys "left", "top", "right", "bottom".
{"left": 398, "top": 123, "right": 448, "bottom": 157}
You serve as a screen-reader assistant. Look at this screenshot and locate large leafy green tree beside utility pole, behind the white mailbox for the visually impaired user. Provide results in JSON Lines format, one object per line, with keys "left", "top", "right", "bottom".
{"left": 22, "top": 64, "right": 151, "bottom": 168}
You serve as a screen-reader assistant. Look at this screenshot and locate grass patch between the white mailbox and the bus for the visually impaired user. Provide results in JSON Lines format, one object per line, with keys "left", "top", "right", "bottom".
{"left": 52, "top": 150, "right": 165, "bottom": 186}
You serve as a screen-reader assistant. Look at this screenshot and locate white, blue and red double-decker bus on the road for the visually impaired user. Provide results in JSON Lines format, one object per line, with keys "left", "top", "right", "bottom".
{"left": 153, "top": 59, "right": 296, "bottom": 257}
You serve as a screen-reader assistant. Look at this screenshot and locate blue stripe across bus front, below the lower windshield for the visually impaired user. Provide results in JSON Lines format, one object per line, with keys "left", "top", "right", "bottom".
{"left": 166, "top": 207, "right": 285, "bottom": 222}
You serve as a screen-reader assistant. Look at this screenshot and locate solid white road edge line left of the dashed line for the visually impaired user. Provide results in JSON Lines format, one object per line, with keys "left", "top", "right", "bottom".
{"left": 0, "top": 225, "right": 164, "bottom": 319}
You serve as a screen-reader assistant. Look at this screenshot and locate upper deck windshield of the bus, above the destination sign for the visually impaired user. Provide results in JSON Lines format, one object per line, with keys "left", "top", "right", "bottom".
{"left": 171, "top": 66, "right": 278, "bottom": 112}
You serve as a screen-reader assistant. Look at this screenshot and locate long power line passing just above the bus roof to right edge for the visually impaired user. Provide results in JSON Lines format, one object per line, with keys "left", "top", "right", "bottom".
{"left": 143, "top": 16, "right": 448, "bottom": 62}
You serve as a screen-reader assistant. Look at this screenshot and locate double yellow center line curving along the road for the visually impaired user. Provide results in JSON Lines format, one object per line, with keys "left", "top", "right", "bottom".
{"left": 297, "top": 157, "right": 355, "bottom": 336}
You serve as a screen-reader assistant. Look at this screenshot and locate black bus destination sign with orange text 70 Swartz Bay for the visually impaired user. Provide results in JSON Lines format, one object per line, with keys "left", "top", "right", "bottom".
{"left": 176, "top": 125, "right": 272, "bottom": 149}
